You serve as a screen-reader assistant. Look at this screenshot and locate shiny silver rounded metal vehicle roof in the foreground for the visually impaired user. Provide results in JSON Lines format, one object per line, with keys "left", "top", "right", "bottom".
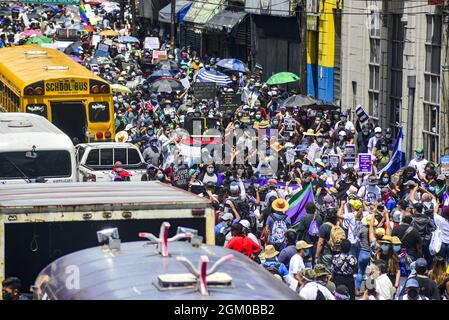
{"left": 36, "top": 242, "right": 299, "bottom": 301}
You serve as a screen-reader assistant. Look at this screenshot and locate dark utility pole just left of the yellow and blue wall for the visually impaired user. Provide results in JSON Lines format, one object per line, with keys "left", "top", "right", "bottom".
{"left": 296, "top": 0, "right": 307, "bottom": 94}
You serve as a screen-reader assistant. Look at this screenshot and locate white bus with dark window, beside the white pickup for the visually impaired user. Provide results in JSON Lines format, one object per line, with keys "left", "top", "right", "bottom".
{"left": 0, "top": 112, "right": 78, "bottom": 184}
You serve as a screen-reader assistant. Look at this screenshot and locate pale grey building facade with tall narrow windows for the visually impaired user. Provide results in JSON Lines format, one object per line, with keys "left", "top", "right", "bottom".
{"left": 334, "top": 0, "right": 449, "bottom": 163}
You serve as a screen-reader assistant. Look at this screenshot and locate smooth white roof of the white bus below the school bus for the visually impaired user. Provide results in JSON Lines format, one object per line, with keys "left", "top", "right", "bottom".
{"left": 0, "top": 112, "right": 74, "bottom": 151}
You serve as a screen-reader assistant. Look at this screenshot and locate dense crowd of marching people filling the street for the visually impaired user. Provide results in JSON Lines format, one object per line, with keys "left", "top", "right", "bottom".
{"left": 0, "top": 2, "right": 449, "bottom": 300}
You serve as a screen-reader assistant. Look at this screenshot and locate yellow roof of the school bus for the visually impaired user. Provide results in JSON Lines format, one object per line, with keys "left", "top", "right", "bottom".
{"left": 0, "top": 45, "right": 106, "bottom": 89}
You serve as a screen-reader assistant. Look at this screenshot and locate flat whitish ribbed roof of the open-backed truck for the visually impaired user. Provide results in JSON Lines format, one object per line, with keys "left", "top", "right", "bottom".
{"left": 0, "top": 181, "right": 211, "bottom": 214}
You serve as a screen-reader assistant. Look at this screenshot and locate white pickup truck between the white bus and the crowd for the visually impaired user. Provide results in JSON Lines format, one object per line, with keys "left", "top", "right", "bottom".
{"left": 76, "top": 142, "right": 147, "bottom": 181}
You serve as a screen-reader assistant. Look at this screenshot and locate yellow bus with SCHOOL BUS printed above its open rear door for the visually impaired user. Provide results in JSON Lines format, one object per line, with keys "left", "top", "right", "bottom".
{"left": 0, "top": 45, "right": 115, "bottom": 142}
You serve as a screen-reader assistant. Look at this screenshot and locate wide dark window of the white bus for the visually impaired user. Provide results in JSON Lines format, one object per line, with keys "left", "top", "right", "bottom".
{"left": 0, "top": 150, "right": 72, "bottom": 179}
